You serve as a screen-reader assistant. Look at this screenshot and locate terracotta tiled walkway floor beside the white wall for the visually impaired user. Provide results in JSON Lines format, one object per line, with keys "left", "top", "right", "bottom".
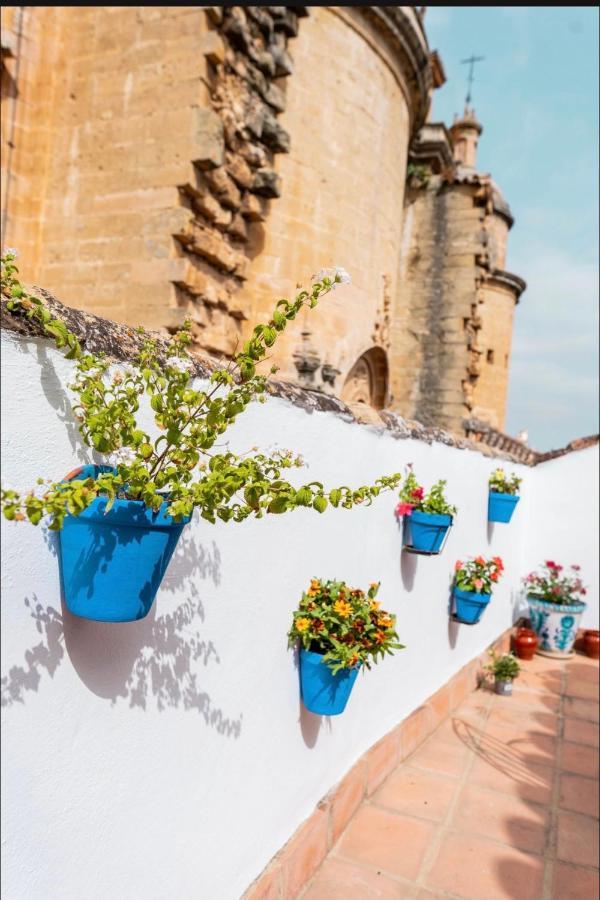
{"left": 302, "top": 655, "right": 599, "bottom": 900}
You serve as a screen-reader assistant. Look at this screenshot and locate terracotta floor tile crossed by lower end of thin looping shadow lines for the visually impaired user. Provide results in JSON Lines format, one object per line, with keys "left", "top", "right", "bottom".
{"left": 469, "top": 753, "right": 554, "bottom": 804}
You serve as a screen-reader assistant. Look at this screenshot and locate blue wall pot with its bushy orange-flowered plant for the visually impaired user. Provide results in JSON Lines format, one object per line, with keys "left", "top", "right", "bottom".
{"left": 288, "top": 578, "right": 403, "bottom": 716}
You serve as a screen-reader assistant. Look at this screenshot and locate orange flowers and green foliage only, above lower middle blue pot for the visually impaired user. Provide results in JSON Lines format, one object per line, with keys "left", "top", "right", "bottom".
{"left": 288, "top": 578, "right": 404, "bottom": 674}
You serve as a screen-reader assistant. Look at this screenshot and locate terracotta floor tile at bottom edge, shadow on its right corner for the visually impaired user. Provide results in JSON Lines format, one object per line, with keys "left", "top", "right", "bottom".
{"left": 426, "top": 834, "right": 544, "bottom": 900}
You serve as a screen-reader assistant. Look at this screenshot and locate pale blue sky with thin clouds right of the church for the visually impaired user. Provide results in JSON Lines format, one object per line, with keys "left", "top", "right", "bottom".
{"left": 425, "top": 6, "right": 599, "bottom": 450}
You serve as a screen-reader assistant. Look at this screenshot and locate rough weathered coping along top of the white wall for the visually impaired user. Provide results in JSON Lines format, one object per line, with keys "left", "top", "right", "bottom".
{"left": 0, "top": 285, "right": 598, "bottom": 466}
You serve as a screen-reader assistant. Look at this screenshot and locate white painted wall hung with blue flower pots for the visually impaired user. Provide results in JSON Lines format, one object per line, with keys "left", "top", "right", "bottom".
{"left": 2, "top": 335, "right": 597, "bottom": 900}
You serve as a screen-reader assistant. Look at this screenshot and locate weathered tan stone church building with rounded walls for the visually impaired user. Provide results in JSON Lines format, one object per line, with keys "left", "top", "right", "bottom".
{"left": 2, "top": 6, "right": 525, "bottom": 434}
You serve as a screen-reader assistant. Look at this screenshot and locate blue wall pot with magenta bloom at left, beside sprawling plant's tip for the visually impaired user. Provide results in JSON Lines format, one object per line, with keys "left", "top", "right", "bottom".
{"left": 396, "top": 465, "right": 456, "bottom": 554}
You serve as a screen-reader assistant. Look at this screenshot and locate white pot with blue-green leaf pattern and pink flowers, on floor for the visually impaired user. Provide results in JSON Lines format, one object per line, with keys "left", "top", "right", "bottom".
{"left": 523, "top": 559, "right": 587, "bottom": 659}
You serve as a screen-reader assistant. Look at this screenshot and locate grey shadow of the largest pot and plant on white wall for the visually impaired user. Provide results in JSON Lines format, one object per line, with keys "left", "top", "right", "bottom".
{"left": 2, "top": 532, "right": 242, "bottom": 738}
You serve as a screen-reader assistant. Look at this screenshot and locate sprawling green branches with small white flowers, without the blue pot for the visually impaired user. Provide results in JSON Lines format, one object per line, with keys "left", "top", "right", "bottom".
{"left": 0, "top": 251, "right": 401, "bottom": 530}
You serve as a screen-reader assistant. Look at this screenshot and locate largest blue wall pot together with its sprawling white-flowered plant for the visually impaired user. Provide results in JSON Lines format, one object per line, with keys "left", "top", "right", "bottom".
{"left": 0, "top": 251, "right": 401, "bottom": 621}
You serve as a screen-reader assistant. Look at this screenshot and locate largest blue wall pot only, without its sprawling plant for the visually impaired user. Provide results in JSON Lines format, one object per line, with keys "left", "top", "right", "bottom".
{"left": 59, "top": 466, "right": 189, "bottom": 622}
